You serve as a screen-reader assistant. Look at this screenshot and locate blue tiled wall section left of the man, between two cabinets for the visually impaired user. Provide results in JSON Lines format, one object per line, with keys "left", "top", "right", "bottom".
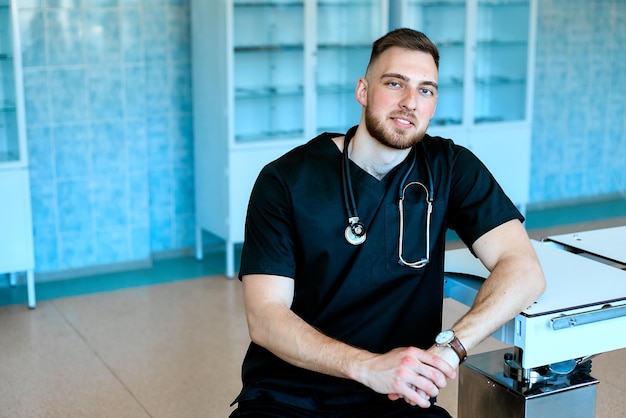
{"left": 19, "top": 0, "right": 194, "bottom": 272}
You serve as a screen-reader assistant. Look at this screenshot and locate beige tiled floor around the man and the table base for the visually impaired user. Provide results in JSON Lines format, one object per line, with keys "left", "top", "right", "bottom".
{"left": 0, "top": 222, "right": 626, "bottom": 418}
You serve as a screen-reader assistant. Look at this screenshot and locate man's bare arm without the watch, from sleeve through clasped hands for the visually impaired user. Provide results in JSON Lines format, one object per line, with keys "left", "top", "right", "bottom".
{"left": 243, "top": 275, "right": 455, "bottom": 407}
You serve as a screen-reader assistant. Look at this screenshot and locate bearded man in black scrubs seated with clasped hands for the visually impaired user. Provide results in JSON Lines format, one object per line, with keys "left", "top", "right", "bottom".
{"left": 231, "top": 29, "right": 545, "bottom": 418}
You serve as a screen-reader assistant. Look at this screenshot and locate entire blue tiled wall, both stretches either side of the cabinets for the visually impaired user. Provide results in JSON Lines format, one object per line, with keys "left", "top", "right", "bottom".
{"left": 14, "top": 0, "right": 626, "bottom": 272}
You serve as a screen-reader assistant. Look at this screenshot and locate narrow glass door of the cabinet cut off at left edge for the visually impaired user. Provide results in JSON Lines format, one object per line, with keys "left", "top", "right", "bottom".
{"left": 0, "top": 0, "right": 20, "bottom": 165}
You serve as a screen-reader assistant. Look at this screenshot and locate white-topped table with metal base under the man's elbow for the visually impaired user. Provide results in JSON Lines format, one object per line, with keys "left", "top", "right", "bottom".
{"left": 445, "top": 238, "right": 626, "bottom": 418}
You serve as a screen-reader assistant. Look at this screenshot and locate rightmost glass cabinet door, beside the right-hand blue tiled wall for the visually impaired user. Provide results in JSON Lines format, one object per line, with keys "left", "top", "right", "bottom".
{"left": 474, "top": 0, "right": 530, "bottom": 123}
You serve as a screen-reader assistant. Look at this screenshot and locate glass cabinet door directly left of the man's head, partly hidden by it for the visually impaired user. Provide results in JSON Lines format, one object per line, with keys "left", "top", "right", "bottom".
{"left": 316, "top": 0, "right": 387, "bottom": 133}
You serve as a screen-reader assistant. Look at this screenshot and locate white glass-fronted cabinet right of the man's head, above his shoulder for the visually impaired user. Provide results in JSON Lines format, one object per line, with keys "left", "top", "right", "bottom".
{"left": 390, "top": 0, "right": 537, "bottom": 212}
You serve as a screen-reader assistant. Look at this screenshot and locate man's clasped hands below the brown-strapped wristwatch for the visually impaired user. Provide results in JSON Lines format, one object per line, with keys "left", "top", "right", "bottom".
{"left": 364, "top": 346, "right": 459, "bottom": 408}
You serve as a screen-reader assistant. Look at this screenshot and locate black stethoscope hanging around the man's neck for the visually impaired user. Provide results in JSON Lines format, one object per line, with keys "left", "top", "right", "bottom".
{"left": 342, "top": 126, "right": 434, "bottom": 268}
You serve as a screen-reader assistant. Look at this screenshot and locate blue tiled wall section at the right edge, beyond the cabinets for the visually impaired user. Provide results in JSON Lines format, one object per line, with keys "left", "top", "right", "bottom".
{"left": 530, "top": 0, "right": 626, "bottom": 202}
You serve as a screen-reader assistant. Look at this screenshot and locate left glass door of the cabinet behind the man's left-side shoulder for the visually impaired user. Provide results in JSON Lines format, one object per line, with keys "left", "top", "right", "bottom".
{"left": 232, "top": 0, "right": 304, "bottom": 143}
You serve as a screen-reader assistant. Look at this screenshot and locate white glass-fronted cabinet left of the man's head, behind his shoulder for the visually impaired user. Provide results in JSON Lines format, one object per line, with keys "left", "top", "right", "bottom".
{"left": 191, "top": 0, "right": 389, "bottom": 276}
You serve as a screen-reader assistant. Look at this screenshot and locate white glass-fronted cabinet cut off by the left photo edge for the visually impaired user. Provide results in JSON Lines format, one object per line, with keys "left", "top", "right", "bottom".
{"left": 0, "top": 0, "right": 35, "bottom": 308}
